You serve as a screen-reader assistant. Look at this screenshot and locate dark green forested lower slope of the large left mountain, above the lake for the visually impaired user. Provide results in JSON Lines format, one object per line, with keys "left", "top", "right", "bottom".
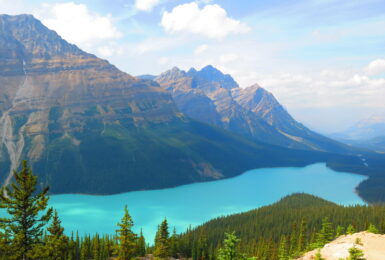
{"left": 33, "top": 119, "right": 360, "bottom": 194}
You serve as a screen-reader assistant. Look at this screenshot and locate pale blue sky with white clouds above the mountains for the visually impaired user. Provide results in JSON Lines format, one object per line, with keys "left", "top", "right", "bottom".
{"left": 0, "top": 0, "right": 385, "bottom": 133}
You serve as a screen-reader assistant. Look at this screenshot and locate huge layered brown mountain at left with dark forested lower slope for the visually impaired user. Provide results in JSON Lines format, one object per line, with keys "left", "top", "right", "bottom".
{"left": 0, "top": 15, "right": 344, "bottom": 194}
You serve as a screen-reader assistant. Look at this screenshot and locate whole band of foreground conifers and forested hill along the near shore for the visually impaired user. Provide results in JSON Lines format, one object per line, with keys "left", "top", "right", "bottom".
{"left": 0, "top": 161, "right": 385, "bottom": 260}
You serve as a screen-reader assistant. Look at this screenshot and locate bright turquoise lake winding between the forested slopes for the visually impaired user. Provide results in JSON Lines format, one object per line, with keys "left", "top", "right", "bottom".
{"left": 50, "top": 164, "right": 366, "bottom": 243}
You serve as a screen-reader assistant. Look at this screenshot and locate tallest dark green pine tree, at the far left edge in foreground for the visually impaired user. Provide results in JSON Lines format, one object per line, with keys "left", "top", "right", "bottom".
{"left": 0, "top": 161, "right": 52, "bottom": 260}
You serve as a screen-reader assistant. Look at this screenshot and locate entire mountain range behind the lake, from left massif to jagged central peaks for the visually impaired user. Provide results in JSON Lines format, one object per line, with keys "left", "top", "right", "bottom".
{"left": 0, "top": 15, "right": 385, "bottom": 199}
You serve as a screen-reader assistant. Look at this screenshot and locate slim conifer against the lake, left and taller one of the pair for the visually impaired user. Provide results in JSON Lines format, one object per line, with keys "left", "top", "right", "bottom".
{"left": 116, "top": 206, "right": 137, "bottom": 260}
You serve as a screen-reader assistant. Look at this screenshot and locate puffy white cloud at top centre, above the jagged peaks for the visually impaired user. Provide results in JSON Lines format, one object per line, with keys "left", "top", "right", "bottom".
{"left": 161, "top": 2, "right": 250, "bottom": 39}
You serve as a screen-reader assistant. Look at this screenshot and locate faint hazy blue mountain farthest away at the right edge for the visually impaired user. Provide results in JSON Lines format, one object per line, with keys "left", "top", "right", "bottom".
{"left": 330, "top": 115, "right": 385, "bottom": 142}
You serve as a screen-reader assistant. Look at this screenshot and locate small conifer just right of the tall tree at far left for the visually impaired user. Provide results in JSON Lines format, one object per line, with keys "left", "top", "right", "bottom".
{"left": 45, "top": 210, "right": 69, "bottom": 260}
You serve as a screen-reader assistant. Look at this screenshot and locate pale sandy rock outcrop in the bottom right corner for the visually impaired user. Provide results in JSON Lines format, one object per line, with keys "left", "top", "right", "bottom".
{"left": 297, "top": 232, "right": 385, "bottom": 260}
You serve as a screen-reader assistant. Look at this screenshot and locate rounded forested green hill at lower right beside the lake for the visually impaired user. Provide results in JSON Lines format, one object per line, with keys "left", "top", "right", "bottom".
{"left": 176, "top": 191, "right": 385, "bottom": 260}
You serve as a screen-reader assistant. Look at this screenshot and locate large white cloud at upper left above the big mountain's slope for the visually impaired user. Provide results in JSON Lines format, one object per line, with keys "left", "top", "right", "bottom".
{"left": 37, "top": 2, "right": 122, "bottom": 48}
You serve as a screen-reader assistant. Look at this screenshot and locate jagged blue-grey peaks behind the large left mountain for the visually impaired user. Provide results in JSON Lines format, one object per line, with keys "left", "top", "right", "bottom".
{"left": 154, "top": 65, "right": 349, "bottom": 152}
